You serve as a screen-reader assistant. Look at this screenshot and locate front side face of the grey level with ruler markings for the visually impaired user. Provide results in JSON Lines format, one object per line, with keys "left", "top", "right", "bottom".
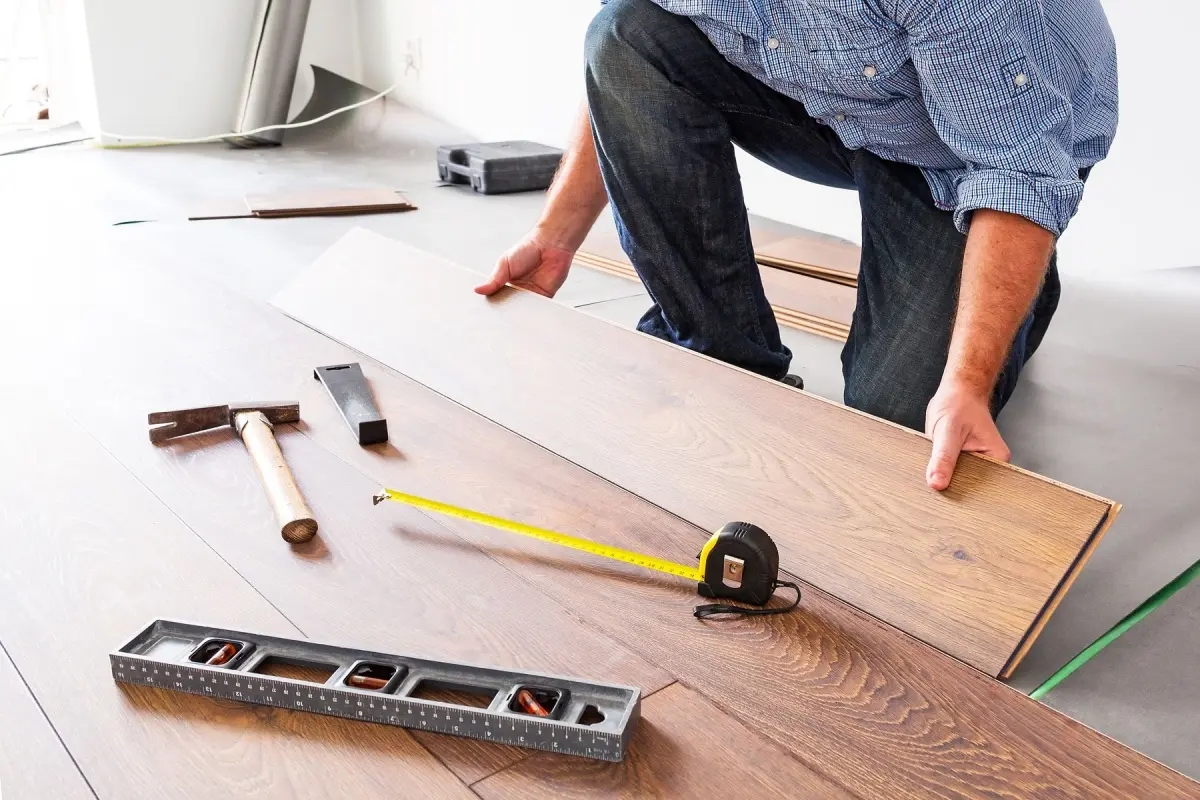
{"left": 113, "top": 657, "right": 620, "bottom": 760}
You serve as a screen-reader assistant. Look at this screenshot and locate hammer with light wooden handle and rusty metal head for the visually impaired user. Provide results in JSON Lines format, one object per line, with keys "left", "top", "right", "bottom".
{"left": 148, "top": 403, "right": 317, "bottom": 545}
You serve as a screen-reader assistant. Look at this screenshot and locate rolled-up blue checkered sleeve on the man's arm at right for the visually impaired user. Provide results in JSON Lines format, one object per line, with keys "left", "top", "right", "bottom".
{"left": 895, "top": 0, "right": 1084, "bottom": 235}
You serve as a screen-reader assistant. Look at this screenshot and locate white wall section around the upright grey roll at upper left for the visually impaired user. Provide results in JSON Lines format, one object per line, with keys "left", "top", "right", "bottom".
{"left": 43, "top": 0, "right": 361, "bottom": 138}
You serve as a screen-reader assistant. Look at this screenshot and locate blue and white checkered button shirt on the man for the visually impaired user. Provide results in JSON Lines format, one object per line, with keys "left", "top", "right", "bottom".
{"left": 614, "top": 0, "right": 1117, "bottom": 234}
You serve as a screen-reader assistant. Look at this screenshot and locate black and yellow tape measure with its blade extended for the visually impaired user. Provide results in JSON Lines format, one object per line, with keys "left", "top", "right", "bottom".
{"left": 373, "top": 488, "right": 800, "bottom": 618}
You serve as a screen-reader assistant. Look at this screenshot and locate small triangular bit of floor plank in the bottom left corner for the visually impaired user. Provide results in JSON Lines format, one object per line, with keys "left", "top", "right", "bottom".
{"left": 0, "top": 642, "right": 96, "bottom": 800}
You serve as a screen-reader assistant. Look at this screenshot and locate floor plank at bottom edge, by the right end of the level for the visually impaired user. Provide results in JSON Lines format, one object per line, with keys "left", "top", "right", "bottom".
{"left": 472, "top": 684, "right": 854, "bottom": 800}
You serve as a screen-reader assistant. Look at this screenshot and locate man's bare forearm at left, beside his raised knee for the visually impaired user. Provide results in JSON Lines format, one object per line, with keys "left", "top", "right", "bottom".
{"left": 538, "top": 103, "right": 608, "bottom": 251}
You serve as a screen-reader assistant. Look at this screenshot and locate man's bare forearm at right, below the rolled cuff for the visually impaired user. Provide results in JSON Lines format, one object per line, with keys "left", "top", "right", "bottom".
{"left": 942, "top": 209, "right": 1055, "bottom": 397}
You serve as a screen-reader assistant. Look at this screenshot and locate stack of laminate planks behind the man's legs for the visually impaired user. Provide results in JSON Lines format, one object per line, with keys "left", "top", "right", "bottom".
{"left": 575, "top": 217, "right": 858, "bottom": 342}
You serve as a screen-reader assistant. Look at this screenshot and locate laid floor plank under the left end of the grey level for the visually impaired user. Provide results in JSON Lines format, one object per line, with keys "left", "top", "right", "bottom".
{"left": 0, "top": 386, "right": 468, "bottom": 798}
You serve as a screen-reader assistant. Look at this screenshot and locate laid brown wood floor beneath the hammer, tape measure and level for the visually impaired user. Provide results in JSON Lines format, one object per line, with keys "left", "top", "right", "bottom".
{"left": 0, "top": 221, "right": 1198, "bottom": 798}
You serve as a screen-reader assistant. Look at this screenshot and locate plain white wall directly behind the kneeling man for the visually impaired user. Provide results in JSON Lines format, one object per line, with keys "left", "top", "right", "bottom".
{"left": 358, "top": 0, "right": 1200, "bottom": 273}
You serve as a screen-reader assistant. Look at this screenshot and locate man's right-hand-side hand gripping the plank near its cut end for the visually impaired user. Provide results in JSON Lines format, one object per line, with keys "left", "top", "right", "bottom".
{"left": 925, "top": 384, "right": 1012, "bottom": 492}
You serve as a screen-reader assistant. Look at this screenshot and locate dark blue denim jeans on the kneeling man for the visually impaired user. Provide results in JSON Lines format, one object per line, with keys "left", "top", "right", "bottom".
{"left": 587, "top": 0, "right": 1058, "bottom": 431}
